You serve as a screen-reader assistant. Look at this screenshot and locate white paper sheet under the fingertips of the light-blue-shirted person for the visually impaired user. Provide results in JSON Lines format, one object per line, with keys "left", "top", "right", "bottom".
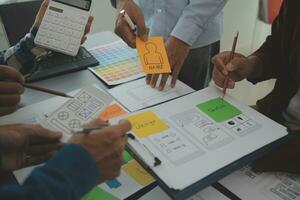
{"left": 108, "top": 77, "right": 195, "bottom": 112}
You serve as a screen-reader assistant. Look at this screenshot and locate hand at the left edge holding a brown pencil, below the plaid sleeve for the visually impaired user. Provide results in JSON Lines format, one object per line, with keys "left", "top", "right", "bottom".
{"left": 0, "top": 65, "right": 24, "bottom": 116}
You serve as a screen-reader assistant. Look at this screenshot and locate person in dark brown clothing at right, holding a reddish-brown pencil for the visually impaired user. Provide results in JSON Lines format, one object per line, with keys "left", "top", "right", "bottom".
{"left": 212, "top": 0, "right": 300, "bottom": 173}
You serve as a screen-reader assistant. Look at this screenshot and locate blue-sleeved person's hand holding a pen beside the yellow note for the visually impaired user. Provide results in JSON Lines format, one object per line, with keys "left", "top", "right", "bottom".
{"left": 69, "top": 120, "right": 131, "bottom": 183}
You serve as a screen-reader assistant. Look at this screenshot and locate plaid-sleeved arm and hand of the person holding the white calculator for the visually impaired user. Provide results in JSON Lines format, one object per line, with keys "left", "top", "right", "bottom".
{"left": 0, "top": 0, "right": 94, "bottom": 75}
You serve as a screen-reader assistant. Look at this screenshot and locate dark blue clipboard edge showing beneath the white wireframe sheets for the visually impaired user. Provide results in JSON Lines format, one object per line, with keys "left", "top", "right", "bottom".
{"left": 126, "top": 130, "right": 293, "bottom": 200}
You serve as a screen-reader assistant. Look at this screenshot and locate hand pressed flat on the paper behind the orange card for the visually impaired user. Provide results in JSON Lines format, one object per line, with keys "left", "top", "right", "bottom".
{"left": 146, "top": 36, "right": 190, "bottom": 91}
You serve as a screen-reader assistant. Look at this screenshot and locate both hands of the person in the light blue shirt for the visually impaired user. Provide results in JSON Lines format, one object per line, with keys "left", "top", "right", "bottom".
{"left": 115, "top": 0, "right": 190, "bottom": 90}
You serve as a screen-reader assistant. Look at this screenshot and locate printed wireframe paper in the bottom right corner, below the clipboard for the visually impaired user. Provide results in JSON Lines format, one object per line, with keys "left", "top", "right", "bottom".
{"left": 219, "top": 166, "right": 300, "bottom": 200}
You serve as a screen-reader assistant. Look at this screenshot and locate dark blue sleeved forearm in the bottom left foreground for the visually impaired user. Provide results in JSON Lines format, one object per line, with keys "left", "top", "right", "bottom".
{"left": 0, "top": 145, "right": 100, "bottom": 200}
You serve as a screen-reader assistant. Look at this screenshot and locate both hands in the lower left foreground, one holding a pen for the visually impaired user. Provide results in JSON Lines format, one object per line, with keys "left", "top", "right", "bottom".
{"left": 0, "top": 120, "right": 131, "bottom": 183}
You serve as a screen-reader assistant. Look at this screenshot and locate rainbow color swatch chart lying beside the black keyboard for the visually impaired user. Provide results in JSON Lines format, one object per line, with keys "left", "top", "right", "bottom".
{"left": 89, "top": 40, "right": 145, "bottom": 85}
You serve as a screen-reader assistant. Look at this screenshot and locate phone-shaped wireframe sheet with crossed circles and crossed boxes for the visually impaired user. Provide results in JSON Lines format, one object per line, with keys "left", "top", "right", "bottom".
{"left": 41, "top": 87, "right": 112, "bottom": 141}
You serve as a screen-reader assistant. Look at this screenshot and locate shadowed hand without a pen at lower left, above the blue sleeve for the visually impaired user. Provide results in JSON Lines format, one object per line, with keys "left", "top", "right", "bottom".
{"left": 0, "top": 124, "right": 63, "bottom": 170}
